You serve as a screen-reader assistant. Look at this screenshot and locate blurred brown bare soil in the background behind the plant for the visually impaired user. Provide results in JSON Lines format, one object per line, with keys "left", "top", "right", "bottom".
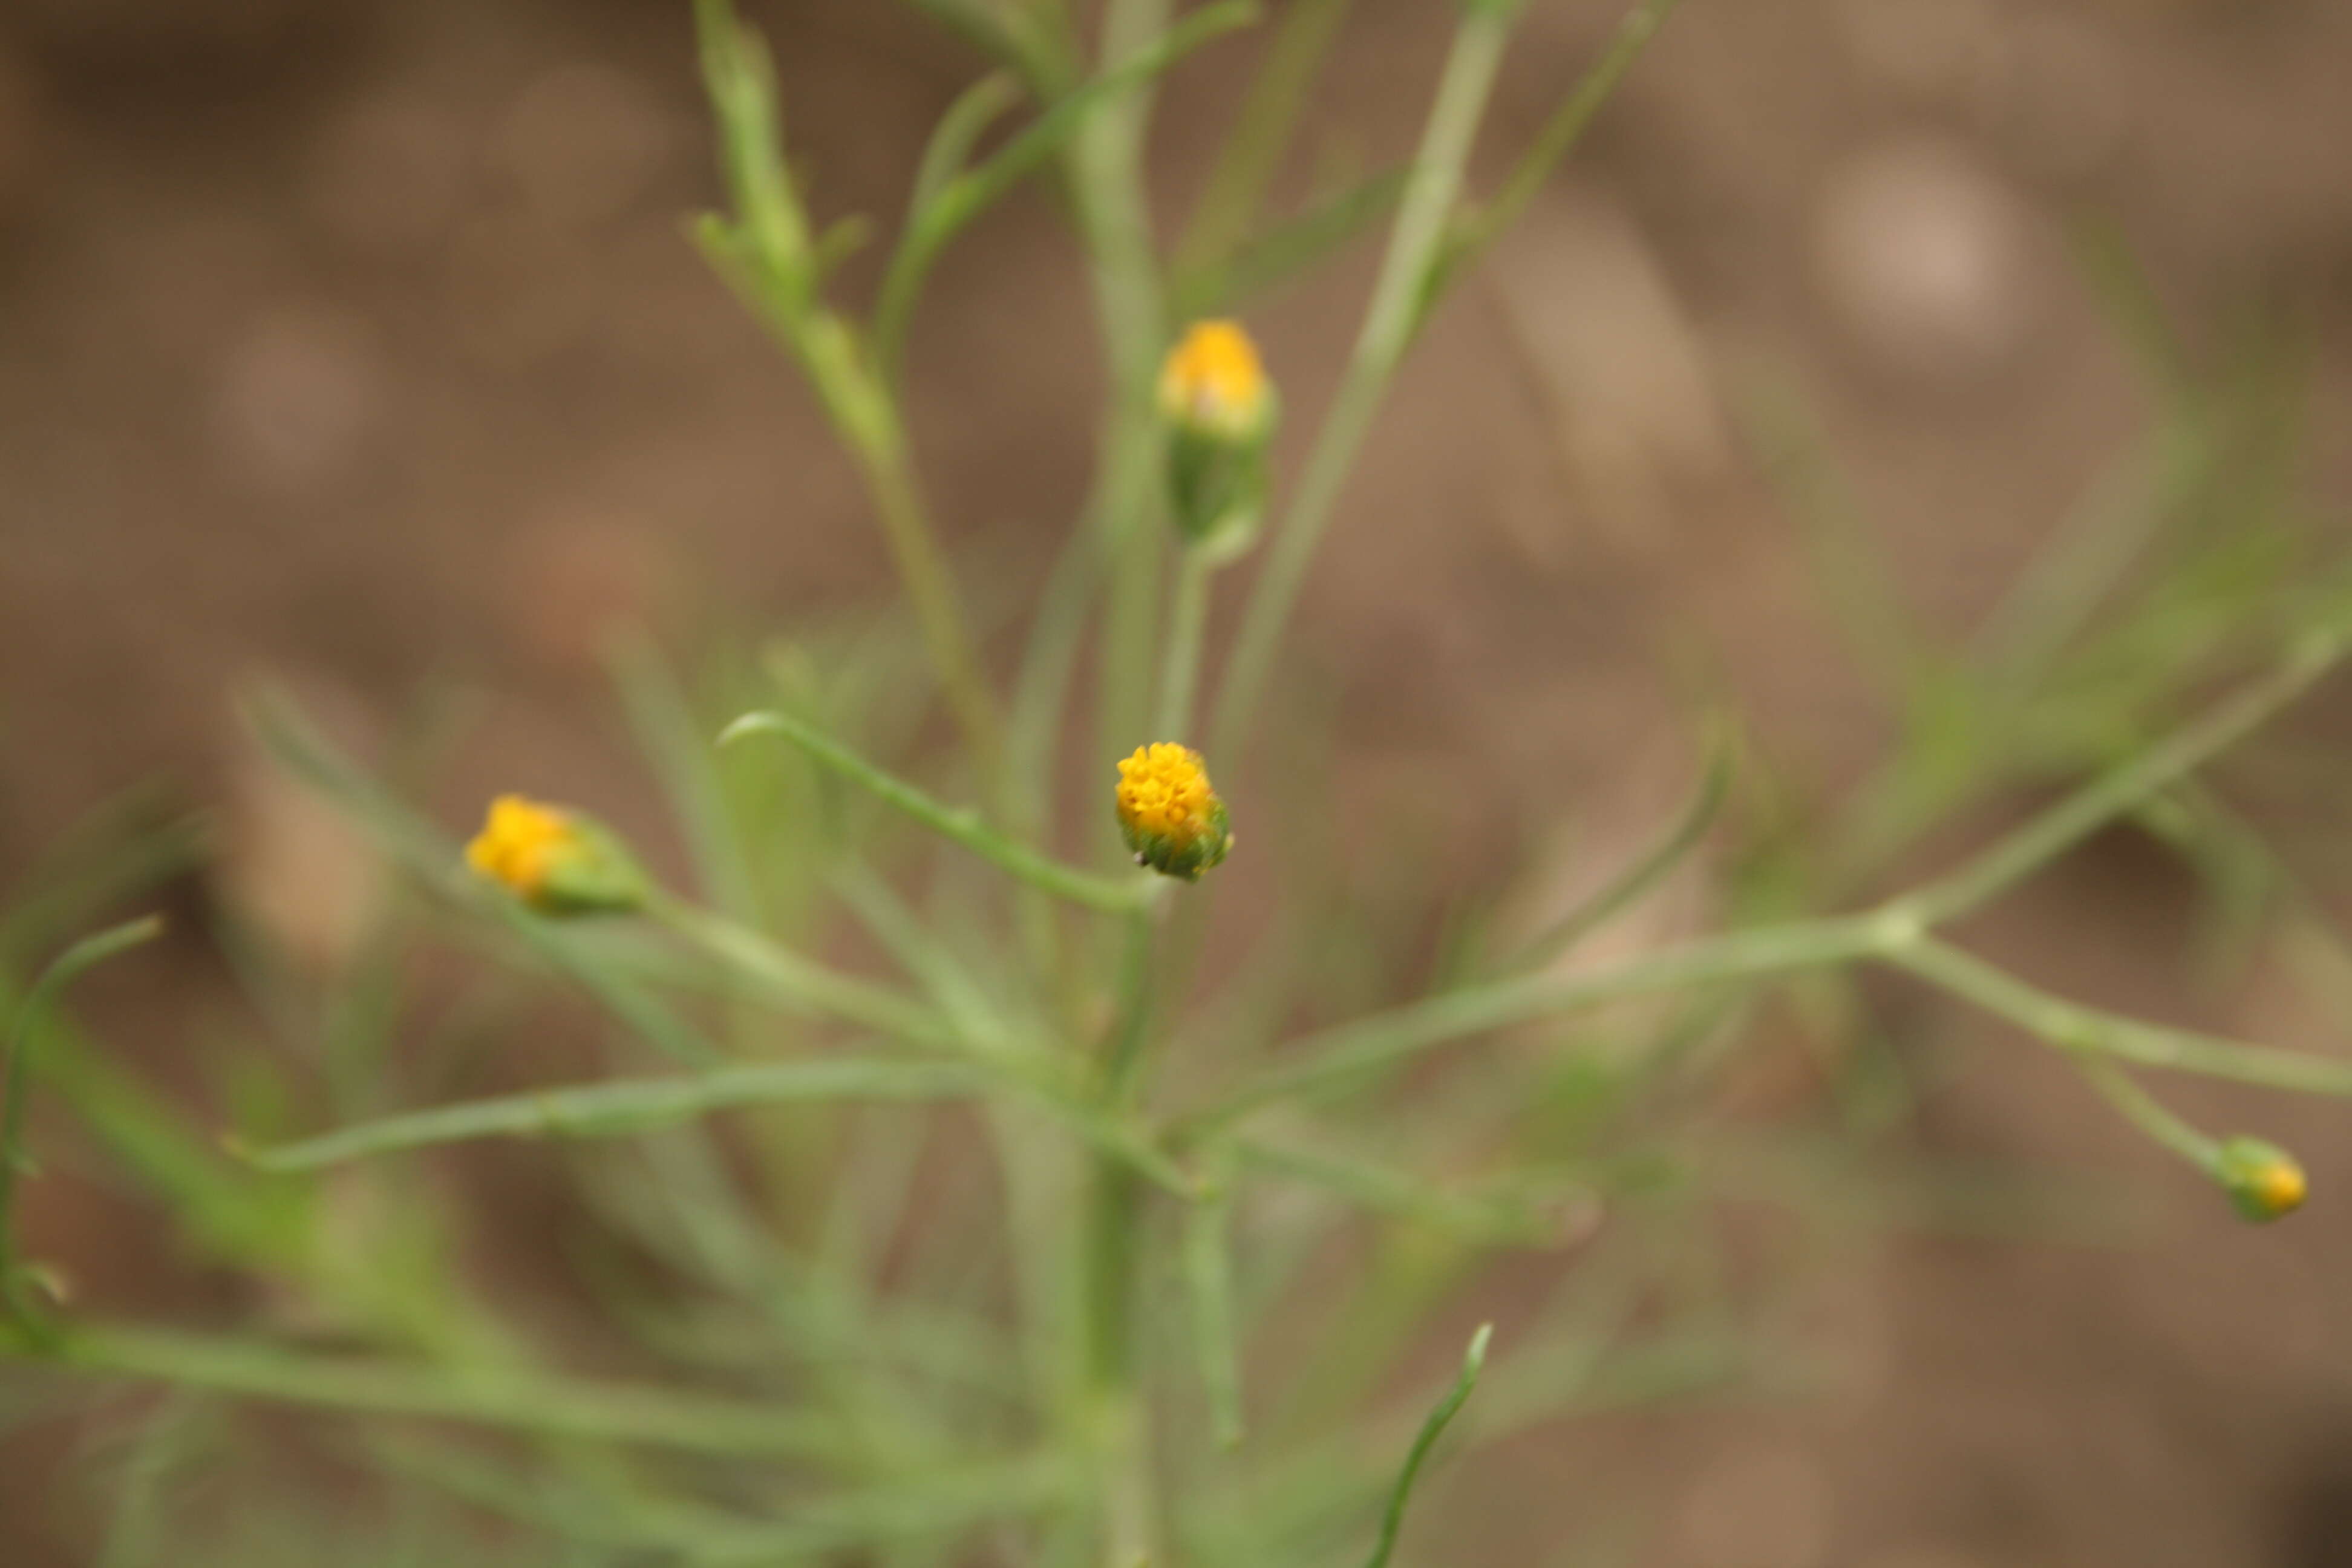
{"left": 0, "top": 0, "right": 2352, "bottom": 1568}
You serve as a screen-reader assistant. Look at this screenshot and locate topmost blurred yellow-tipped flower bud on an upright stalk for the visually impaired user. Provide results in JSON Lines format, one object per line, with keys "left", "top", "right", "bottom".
{"left": 1160, "top": 322, "right": 1279, "bottom": 555}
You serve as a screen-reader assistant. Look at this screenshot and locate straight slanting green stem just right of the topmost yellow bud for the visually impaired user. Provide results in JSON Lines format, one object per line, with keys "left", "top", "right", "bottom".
{"left": 1209, "top": 7, "right": 1512, "bottom": 766}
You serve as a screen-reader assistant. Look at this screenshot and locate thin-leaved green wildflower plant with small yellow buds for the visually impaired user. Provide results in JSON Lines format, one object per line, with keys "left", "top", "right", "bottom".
{"left": 0, "top": 0, "right": 2352, "bottom": 1568}
